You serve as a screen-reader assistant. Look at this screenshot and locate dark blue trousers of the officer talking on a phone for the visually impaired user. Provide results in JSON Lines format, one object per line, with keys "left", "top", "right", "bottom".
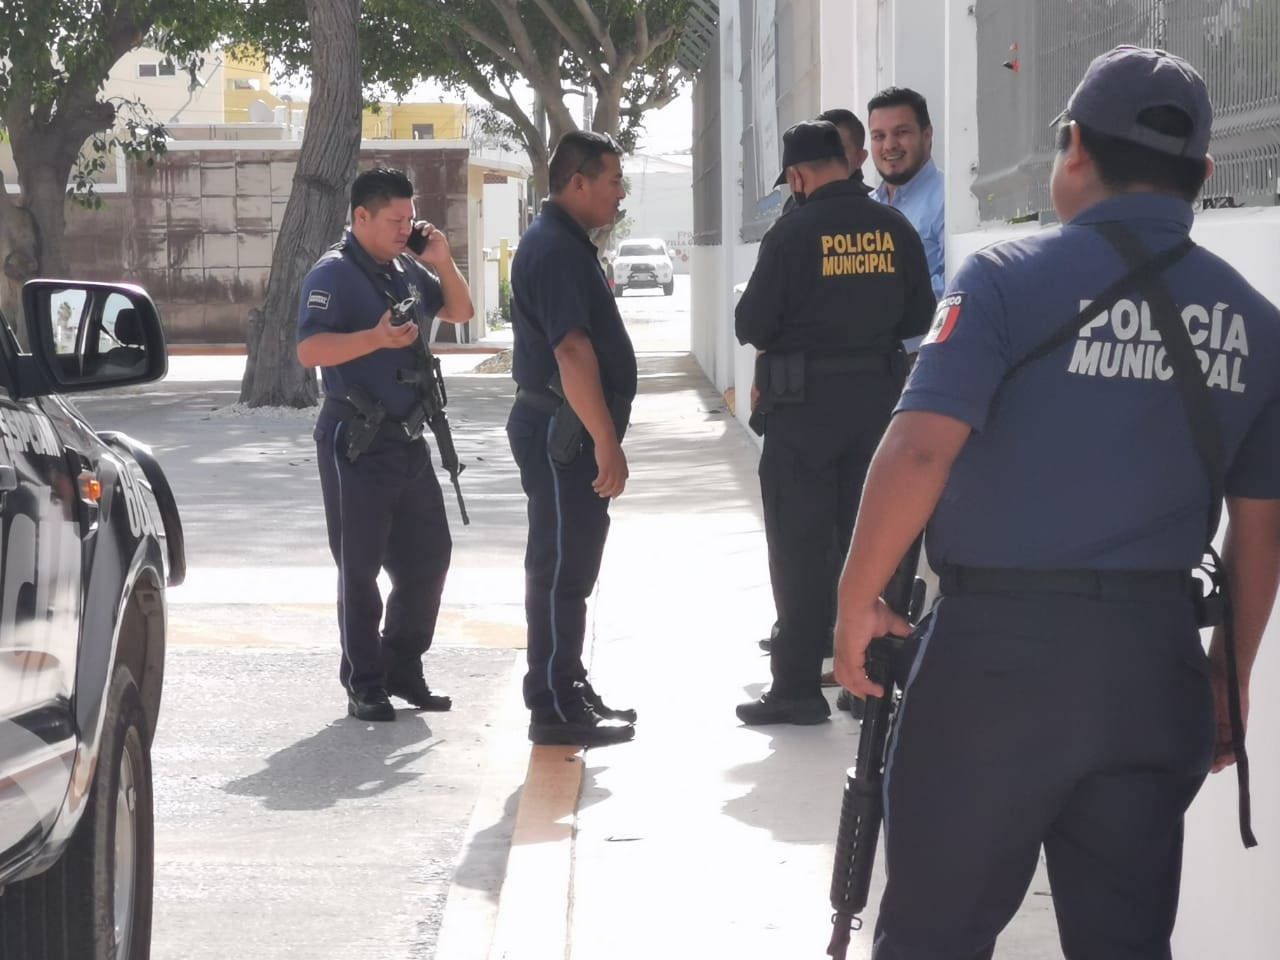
{"left": 315, "top": 420, "right": 453, "bottom": 690}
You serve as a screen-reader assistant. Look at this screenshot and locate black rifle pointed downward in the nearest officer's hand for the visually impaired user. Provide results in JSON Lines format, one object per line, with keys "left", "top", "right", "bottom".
{"left": 827, "top": 538, "right": 924, "bottom": 960}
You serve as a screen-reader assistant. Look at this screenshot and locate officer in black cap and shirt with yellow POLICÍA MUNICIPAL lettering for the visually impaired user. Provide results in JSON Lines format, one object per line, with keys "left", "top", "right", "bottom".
{"left": 735, "top": 120, "right": 934, "bottom": 724}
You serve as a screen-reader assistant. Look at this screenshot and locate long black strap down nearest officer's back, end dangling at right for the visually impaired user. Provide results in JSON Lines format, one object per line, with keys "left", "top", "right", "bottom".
{"left": 1093, "top": 223, "right": 1258, "bottom": 847}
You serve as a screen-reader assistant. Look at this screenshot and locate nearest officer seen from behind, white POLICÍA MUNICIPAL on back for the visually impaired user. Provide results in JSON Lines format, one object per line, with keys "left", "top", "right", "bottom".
{"left": 836, "top": 46, "right": 1280, "bottom": 960}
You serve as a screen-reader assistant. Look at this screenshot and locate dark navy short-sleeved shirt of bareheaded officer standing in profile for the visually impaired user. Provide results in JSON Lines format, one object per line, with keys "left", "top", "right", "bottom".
{"left": 511, "top": 200, "right": 636, "bottom": 399}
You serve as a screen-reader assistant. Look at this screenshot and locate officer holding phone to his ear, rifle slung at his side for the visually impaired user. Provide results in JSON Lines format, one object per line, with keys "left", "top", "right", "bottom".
{"left": 298, "top": 168, "right": 474, "bottom": 721}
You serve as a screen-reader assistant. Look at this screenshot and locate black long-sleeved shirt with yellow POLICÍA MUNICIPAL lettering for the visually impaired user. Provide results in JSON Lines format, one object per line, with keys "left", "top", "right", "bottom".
{"left": 733, "top": 180, "right": 934, "bottom": 355}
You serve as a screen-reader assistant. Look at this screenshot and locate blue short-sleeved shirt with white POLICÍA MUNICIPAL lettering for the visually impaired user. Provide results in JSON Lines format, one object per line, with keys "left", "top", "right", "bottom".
{"left": 897, "top": 195, "right": 1280, "bottom": 570}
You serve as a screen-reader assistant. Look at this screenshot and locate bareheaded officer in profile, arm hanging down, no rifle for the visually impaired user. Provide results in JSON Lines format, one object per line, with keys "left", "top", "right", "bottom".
{"left": 507, "top": 131, "right": 636, "bottom": 746}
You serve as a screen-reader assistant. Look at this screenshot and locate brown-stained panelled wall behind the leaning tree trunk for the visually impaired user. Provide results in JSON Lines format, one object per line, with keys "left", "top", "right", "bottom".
{"left": 58, "top": 142, "right": 471, "bottom": 343}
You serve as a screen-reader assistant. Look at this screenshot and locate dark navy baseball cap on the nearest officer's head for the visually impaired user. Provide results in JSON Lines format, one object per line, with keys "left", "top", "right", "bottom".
{"left": 1053, "top": 45, "right": 1213, "bottom": 160}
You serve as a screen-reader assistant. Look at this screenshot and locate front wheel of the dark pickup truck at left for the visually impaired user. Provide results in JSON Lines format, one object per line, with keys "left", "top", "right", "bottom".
{"left": 63, "top": 664, "right": 155, "bottom": 960}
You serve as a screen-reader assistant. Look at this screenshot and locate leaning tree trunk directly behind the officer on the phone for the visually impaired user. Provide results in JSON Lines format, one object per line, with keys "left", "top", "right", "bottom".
{"left": 241, "top": 0, "right": 361, "bottom": 407}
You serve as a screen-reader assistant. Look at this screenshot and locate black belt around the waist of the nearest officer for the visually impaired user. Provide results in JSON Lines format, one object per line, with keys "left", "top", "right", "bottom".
{"left": 938, "top": 567, "right": 1199, "bottom": 598}
